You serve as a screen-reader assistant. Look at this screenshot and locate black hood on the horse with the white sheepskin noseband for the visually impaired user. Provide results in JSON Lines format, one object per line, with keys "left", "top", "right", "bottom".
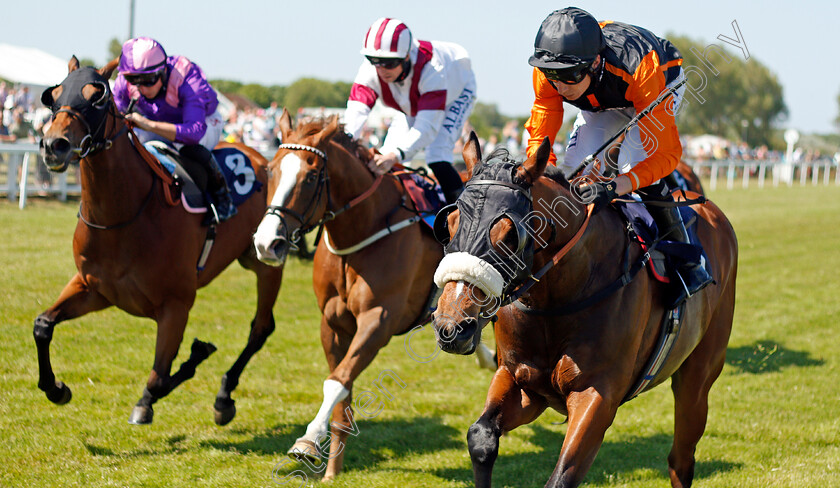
{"left": 435, "top": 151, "right": 534, "bottom": 296}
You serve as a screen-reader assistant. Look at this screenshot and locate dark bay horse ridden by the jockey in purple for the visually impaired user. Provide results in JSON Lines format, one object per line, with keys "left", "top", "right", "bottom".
{"left": 34, "top": 56, "right": 283, "bottom": 425}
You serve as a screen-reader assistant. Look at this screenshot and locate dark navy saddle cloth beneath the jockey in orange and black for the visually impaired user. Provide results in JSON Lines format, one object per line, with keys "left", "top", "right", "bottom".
{"left": 613, "top": 200, "right": 712, "bottom": 294}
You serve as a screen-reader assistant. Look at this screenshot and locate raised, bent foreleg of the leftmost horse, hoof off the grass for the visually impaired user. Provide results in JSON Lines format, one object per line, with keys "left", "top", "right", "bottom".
{"left": 32, "top": 275, "right": 111, "bottom": 405}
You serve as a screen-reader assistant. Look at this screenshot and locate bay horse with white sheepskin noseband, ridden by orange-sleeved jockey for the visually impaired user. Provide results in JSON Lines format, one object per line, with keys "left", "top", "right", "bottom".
{"left": 433, "top": 134, "right": 737, "bottom": 488}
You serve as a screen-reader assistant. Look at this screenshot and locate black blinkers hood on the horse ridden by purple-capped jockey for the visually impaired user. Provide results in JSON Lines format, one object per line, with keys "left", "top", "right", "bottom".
{"left": 41, "top": 66, "right": 111, "bottom": 137}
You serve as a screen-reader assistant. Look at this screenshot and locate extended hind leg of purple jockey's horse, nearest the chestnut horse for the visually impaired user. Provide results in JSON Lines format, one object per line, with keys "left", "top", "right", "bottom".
{"left": 213, "top": 262, "right": 283, "bottom": 425}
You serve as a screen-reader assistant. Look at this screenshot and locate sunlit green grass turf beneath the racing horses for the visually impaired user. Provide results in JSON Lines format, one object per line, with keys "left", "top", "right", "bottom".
{"left": 0, "top": 185, "right": 840, "bottom": 488}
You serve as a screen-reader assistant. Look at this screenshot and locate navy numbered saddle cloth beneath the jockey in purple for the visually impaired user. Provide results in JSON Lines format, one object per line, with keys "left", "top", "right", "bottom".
{"left": 144, "top": 141, "right": 262, "bottom": 221}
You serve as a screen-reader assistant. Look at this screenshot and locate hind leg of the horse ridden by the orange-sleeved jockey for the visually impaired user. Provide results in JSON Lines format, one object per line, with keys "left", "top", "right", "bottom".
{"left": 668, "top": 300, "right": 732, "bottom": 488}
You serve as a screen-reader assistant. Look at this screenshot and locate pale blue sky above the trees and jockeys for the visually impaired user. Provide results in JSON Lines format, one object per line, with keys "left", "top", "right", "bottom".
{"left": 6, "top": 0, "right": 840, "bottom": 133}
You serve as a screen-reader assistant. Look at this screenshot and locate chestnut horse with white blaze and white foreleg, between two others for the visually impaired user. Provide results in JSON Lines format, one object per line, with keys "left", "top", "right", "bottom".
{"left": 254, "top": 109, "right": 450, "bottom": 480}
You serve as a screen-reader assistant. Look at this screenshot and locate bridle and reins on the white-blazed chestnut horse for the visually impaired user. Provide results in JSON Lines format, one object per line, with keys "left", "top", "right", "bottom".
{"left": 265, "top": 144, "right": 383, "bottom": 251}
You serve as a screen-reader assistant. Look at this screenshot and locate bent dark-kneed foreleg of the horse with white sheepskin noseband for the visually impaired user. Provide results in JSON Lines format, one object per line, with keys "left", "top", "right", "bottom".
{"left": 467, "top": 367, "right": 546, "bottom": 488}
